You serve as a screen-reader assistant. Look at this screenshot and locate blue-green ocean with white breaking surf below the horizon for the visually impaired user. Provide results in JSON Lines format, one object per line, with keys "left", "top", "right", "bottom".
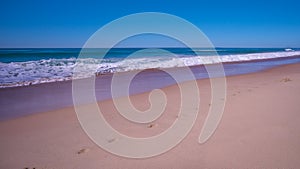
{"left": 0, "top": 48, "right": 300, "bottom": 88}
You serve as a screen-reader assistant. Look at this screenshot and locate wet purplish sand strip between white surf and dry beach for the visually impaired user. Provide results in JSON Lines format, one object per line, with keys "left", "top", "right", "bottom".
{"left": 0, "top": 56, "right": 300, "bottom": 121}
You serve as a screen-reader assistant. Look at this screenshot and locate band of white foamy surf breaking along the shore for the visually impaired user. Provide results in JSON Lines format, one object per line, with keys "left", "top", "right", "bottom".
{"left": 0, "top": 51, "right": 300, "bottom": 88}
